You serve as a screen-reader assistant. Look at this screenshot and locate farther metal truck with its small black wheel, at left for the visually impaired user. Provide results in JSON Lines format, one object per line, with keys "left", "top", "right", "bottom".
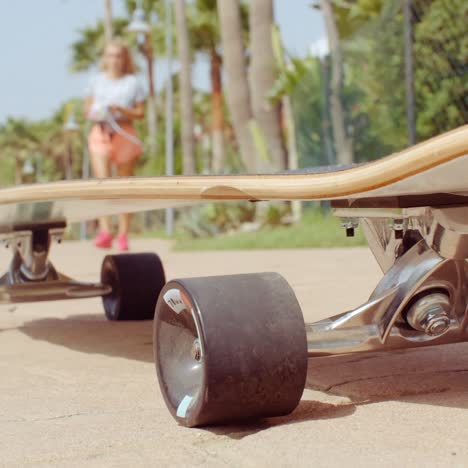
{"left": 0, "top": 221, "right": 165, "bottom": 320}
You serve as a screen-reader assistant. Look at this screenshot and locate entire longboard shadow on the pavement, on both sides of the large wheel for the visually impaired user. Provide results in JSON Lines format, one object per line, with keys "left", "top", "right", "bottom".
{"left": 19, "top": 314, "right": 468, "bottom": 439}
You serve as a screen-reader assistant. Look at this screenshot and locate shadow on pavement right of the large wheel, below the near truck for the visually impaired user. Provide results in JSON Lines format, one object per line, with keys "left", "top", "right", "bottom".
{"left": 306, "top": 342, "right": 468, "bottom": 408}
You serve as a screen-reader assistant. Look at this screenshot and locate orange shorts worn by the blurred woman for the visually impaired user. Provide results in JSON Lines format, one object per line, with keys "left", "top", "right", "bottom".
{"left": 88, "top": 122, "right": 141, "bottom": 164}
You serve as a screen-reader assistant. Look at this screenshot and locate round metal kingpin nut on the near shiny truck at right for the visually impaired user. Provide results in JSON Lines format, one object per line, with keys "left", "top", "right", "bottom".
{"left": 406, "top": 293, "right": 451, "bottom": 336}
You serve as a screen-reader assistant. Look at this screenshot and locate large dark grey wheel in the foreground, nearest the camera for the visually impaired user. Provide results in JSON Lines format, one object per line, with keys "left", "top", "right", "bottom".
{"left": 153, "top": 273, "right": 307, "bottom": 427}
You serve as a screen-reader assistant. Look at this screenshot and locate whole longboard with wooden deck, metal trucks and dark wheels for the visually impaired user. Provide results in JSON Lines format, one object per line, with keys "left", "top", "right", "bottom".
{"left": 0, "top": 126, "right": 468, "bottom": 426}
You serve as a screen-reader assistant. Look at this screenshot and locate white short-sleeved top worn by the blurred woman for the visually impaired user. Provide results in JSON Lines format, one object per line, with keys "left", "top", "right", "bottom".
{"left": 85, "top": 72, "right": 146, "bottom": 120}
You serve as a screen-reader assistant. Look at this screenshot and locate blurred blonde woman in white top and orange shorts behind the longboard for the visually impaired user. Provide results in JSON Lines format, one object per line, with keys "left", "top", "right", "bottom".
{"left": 85, "top": 39, "right": 145, "bottom": 251}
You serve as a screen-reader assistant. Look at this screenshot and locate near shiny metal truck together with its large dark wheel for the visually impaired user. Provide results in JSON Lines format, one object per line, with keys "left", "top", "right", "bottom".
{"left": 154, "top": 203, "right": 468, "bottom": 426}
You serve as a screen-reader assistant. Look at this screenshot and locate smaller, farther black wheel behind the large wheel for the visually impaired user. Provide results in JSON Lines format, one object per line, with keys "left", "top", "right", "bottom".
{"left": 101, "top": 253, "right": 166, "bottom": 320}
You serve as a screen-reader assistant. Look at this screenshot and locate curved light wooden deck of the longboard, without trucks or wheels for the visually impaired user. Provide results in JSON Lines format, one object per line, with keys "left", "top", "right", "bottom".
{"left": 0, "top": 125, "right": 468, "bottom": 231}
